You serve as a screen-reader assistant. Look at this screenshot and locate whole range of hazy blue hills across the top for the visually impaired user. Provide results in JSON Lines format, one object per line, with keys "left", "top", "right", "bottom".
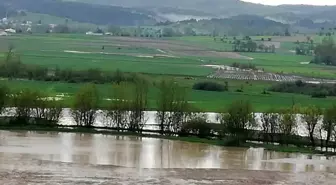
{"left": 0, "top": 0, "right": 336, "bottom": 34}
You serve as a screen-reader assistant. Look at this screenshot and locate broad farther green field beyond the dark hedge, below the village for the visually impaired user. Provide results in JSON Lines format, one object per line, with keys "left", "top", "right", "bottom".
{"left": 0, "top": 34, "right": 336, "bottom": 78}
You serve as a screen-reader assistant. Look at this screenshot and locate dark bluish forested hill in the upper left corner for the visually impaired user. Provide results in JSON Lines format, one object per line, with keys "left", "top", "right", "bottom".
{"left": 0, "top": 0, "right": 155, "bottom": 26}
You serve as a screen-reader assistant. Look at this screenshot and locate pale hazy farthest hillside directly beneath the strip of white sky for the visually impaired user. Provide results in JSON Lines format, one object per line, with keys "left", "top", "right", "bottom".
{"left": 64, "top": 0, "right": 336, "bottom": 21}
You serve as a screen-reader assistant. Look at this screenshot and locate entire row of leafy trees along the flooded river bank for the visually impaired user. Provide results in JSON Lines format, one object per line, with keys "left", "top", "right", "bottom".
{"left": 0, "top": 78, "right": 336, "bottom": 152}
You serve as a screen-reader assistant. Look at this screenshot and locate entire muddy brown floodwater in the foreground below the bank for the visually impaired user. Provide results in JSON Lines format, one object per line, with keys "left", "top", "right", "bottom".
{"left": 0, "top": 131, "right": 336, "bottom": 185}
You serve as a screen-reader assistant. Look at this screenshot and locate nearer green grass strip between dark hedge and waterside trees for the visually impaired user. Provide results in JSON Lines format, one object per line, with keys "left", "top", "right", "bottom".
{"left": 2, "top": 76, "right": 336, "bottom": 112}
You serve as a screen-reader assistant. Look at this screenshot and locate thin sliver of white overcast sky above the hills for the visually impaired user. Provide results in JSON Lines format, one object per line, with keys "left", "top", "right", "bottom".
{"left": 243, "top": 0, "right": 336, "bottom": 5}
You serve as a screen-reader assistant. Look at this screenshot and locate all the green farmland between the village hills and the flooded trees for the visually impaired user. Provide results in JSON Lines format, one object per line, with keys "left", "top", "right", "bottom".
{"left": 0, "top": 34, "right": 336, "bottom": 111}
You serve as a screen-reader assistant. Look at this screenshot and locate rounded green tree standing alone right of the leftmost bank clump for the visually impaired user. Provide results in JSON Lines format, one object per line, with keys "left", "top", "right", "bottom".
{"left": 71, "top": 84, "right": 99, "bottom": 127}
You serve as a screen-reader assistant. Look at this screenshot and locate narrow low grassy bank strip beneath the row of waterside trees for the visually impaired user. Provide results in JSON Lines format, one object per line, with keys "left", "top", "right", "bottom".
{"left": 0, "top": 125, "right": 326, "bottom": 156}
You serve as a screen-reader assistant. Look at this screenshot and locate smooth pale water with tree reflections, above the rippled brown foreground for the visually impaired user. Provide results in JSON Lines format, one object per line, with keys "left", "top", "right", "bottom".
{"left": 0, "top": 131, "right": 336, "bottom": 172}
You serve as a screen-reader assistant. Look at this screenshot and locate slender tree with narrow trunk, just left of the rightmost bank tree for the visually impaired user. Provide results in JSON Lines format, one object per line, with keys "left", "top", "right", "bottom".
{"left": 301, "top": 106, "right": 322, "bottom": 148}
